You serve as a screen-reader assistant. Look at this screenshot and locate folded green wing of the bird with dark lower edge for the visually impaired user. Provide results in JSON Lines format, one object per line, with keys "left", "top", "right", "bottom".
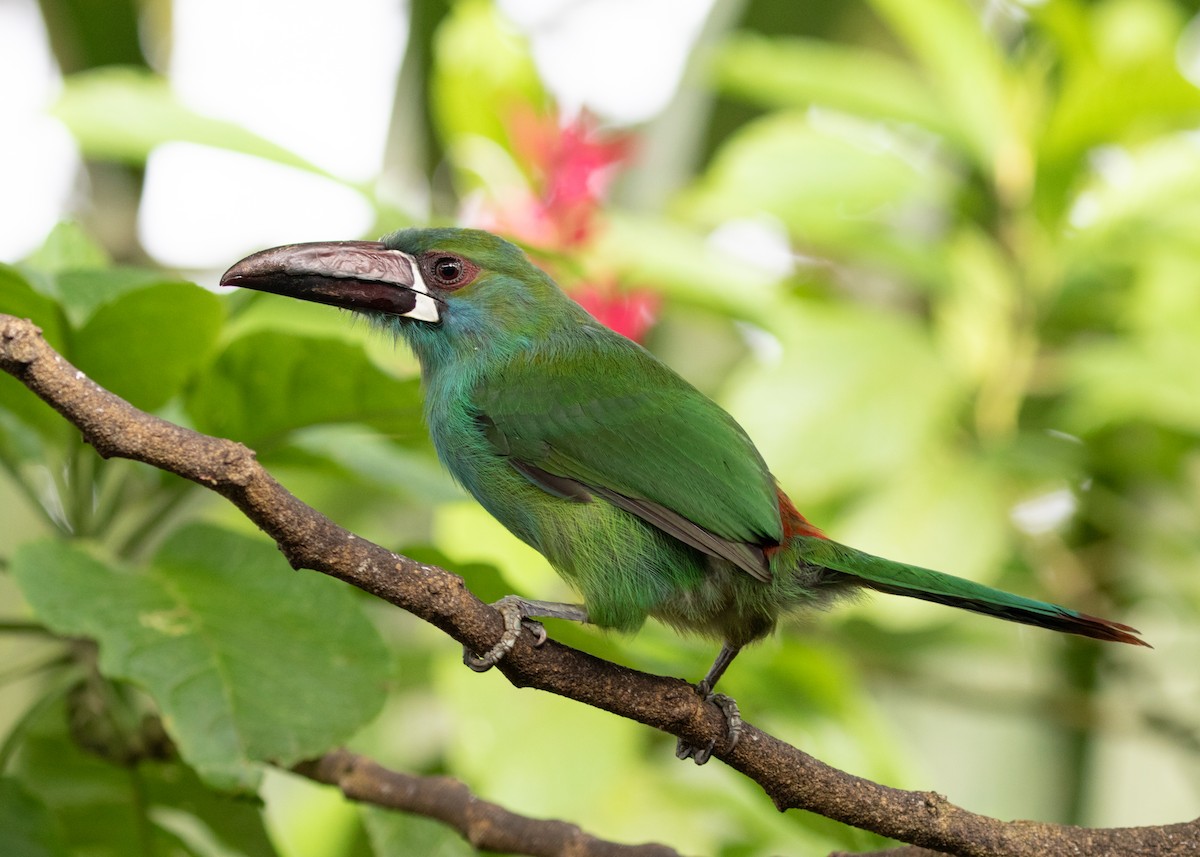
{"left": 473, "top": 337, "right": 782, "bottom": 580}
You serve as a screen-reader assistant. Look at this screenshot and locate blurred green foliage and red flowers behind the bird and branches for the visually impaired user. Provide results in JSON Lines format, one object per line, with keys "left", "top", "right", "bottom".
{"left": 0, "top": 0, "right": 1200, "bottom": 857}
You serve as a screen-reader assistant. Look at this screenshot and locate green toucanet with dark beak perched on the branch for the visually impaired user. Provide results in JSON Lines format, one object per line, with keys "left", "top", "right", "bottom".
{"left": 221, "top": 229, "right": 1146, "bottom": 761}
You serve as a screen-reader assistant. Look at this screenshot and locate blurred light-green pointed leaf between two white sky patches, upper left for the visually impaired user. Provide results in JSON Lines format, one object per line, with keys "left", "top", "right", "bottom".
{"left": 54, "top": 66, "right": 329, "bottom": 176}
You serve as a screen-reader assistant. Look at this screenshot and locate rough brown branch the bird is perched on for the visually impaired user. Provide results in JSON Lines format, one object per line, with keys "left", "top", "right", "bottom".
{"left": 0, "top": 314, "right": 1200, "bottom": 857}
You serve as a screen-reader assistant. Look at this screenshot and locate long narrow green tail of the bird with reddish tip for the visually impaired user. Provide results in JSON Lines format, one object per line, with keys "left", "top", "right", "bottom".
{"left": 797, "top": 535, "right": 1150, "bottom": 647}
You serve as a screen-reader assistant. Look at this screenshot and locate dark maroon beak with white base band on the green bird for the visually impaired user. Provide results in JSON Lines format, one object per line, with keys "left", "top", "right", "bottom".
{"left": 221, "top": 241, "right": 440, "bottom": 323}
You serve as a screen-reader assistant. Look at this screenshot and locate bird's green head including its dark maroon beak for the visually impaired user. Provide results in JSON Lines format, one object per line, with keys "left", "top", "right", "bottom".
{"left": 221, "top": 229, "right": 588, "bottom": 364}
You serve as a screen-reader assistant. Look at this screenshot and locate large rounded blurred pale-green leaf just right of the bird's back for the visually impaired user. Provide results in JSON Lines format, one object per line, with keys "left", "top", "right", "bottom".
{"left": 730, "top": 305, "right": 956, "bottom": 503}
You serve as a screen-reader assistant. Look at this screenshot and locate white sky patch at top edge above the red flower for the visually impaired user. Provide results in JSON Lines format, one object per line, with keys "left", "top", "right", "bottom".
{"left": 498, "top": 0, "right": 712, "bottom": 124}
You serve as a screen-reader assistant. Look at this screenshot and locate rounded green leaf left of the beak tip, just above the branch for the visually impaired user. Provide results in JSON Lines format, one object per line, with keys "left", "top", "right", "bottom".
{"left": 71, "top": 283, "right": 224, "bottom": 410}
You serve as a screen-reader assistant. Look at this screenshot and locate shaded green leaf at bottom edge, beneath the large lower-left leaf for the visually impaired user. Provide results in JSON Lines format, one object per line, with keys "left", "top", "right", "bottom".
{"left": 12, "top": 705, "right": 275, "bottom": 857}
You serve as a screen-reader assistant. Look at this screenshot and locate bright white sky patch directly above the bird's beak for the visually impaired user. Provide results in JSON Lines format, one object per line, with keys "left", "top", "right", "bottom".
{"left": 138, "top": 143, "right": 374, "bottom": 269}
